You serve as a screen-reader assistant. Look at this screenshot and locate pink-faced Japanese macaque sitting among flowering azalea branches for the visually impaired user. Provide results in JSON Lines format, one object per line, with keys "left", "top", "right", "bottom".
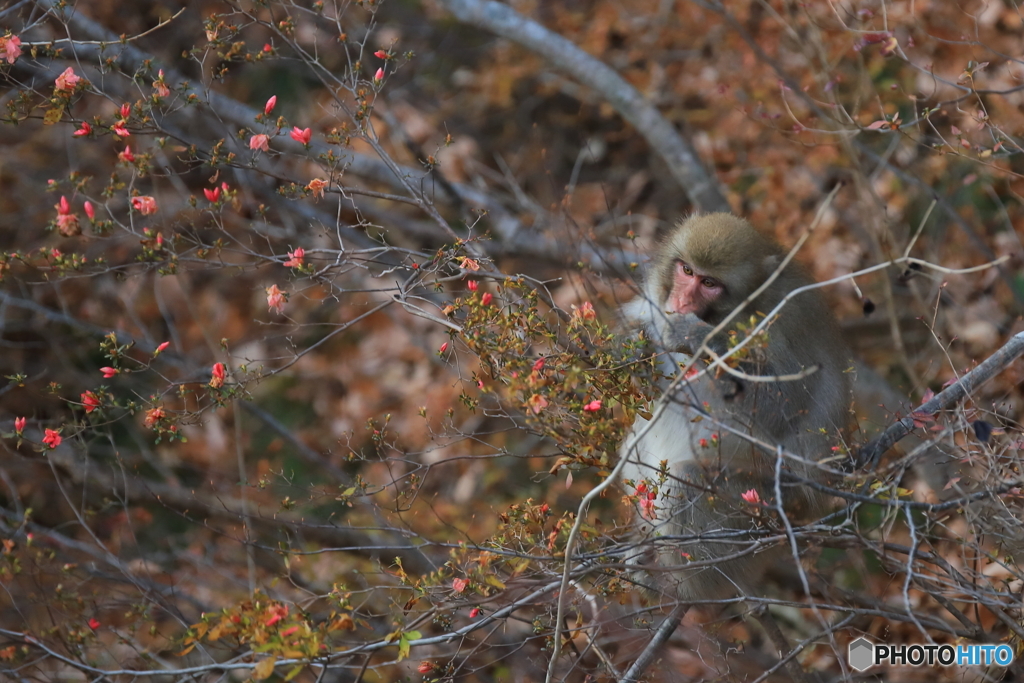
{"left": 622, "top": 213, "right": 851, "bottom": 601}
